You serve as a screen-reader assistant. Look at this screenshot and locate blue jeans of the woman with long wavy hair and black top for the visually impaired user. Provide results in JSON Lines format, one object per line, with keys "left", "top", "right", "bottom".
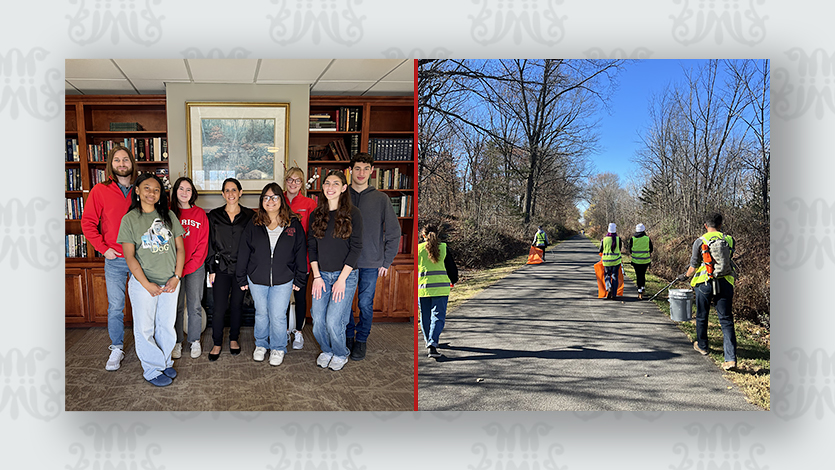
{"left": 310, "top": 269, "right": 359, "bottom": 358}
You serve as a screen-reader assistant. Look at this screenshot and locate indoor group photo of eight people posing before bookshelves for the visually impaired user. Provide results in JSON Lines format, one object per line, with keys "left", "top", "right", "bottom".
{"left": 64, "top": 59, "right": 417, "bottom": 411}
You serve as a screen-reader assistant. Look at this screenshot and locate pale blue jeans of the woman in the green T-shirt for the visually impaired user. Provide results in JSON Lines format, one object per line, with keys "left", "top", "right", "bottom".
{"left": 128, "top": 276, "right": 180, "bottom": 380}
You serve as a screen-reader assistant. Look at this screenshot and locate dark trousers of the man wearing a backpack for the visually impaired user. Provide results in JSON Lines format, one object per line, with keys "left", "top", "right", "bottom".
{"left": 695, "top": 279, "right": 736, "bottom": 361}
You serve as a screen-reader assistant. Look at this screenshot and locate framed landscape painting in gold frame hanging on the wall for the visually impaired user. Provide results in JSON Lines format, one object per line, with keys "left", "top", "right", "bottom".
{"left": 186, "top": 102, "right": 290, "bottom": 193}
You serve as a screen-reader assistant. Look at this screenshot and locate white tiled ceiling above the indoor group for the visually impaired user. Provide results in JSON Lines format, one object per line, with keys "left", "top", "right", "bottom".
{"left": 65, "top": 59, "right": 414, "bottom": 96}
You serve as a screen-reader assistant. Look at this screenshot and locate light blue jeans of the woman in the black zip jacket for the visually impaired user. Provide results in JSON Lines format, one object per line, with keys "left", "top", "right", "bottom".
{"left": 247, "top": 277, "right": 293, "bottom": 352}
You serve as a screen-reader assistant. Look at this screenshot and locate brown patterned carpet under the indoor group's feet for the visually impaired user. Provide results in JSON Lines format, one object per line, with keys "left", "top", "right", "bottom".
{"left": 65, "top": 323, "right": 414, "bottom": 411}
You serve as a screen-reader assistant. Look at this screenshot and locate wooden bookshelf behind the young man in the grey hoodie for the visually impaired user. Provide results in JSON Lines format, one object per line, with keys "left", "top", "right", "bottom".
{"left": 306, "top": 96, "right": 417, "bottom": 321}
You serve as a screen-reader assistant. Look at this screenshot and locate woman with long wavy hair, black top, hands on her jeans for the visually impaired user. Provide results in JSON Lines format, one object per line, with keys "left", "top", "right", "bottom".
{"left": 307, "top": 170, "right": 362, "bottom": 370}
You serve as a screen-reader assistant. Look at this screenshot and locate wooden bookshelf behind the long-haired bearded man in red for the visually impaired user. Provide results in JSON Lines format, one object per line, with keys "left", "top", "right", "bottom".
{"left": 64, "top": 95, "right": 168, "bottom": 326}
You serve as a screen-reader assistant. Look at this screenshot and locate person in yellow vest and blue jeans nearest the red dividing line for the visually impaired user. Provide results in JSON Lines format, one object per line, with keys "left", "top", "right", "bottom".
{"left": 418, "top": 224, "right": 458, "bottom": 358}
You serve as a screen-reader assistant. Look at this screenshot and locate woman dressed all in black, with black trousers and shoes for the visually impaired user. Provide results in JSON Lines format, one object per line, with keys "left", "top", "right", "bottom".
{"left": 206, "top": 178, "right": 255, "bottom": 361}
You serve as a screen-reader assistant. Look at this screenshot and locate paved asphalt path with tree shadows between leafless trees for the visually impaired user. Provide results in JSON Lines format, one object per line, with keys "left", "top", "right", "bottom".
{"left": 418, "top": 236, "right": 760, "bottom": 411}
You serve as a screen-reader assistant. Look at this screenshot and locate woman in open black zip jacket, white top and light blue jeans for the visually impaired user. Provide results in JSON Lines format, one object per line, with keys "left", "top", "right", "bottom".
{"left": 236, "top": 183, "right": 307, "bottom": 366}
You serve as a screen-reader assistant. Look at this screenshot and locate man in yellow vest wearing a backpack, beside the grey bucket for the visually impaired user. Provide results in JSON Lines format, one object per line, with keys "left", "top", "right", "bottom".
{"left": 677, "top": 212, "right": 736, "bottom": 370}
